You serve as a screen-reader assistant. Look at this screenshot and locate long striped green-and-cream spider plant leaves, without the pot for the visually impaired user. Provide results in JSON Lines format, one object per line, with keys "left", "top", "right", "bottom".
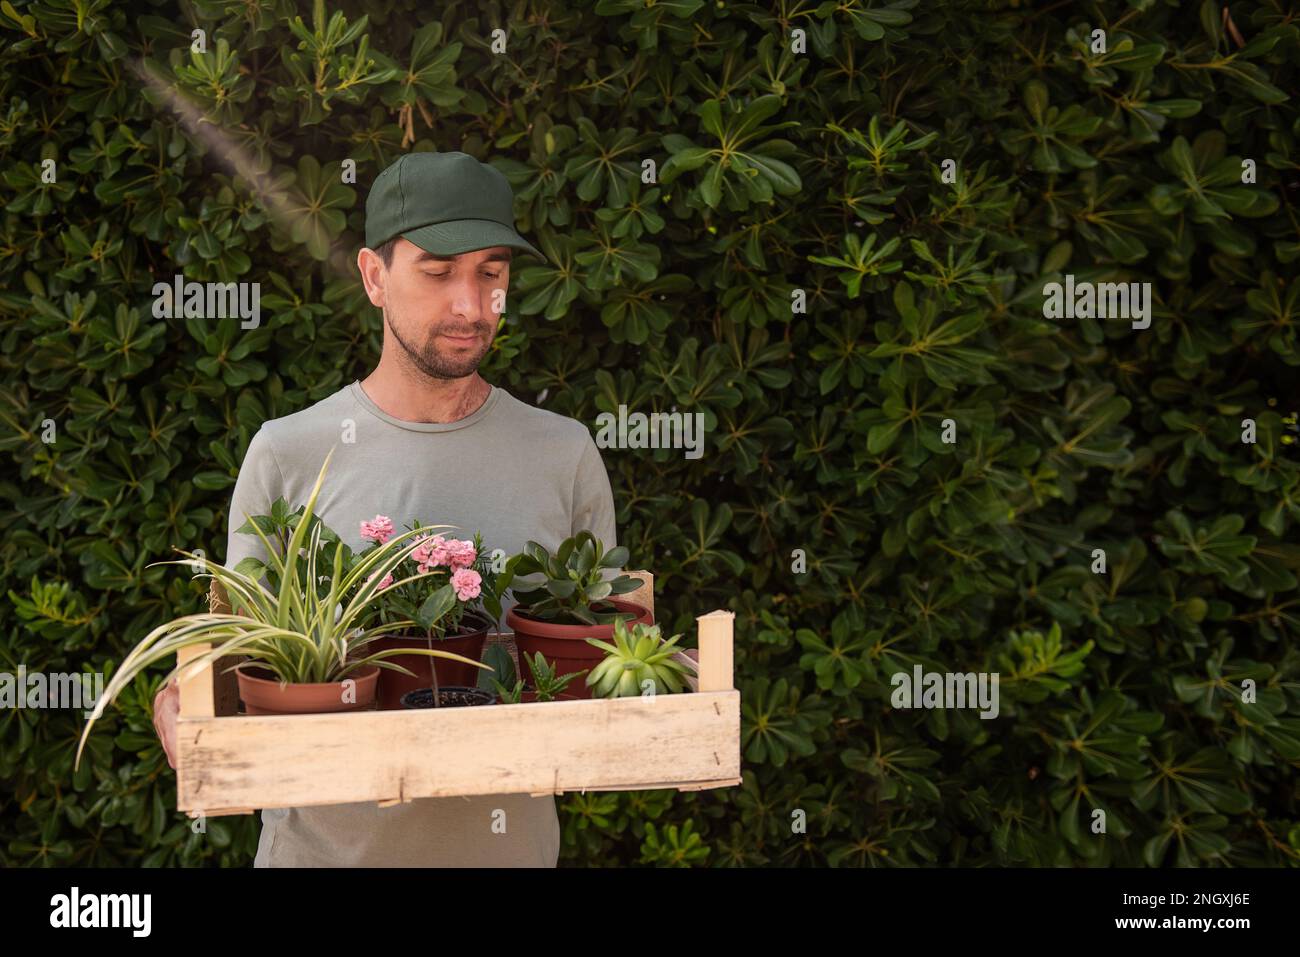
{"left": 77, "top": 449, "right": 488, "bottom": 765}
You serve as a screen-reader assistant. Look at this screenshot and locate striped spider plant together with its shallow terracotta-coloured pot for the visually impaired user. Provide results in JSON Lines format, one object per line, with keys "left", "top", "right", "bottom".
{"left": 77, "top": 450, "right": 484, "bottom": 762}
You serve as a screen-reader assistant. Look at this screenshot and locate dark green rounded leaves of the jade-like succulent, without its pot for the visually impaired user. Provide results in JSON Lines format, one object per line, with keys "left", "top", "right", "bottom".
{"left": 498, "top": 531, "right": 641, "bottom": 624}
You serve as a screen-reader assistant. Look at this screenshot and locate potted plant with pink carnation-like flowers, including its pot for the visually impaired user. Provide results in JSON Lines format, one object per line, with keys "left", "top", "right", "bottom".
{"left": 360, "top": 515, "right": 501, "bottom": 710}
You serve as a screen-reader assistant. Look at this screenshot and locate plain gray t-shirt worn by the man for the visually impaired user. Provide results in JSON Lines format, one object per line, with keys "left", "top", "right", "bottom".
{"left": 226, "top": 382, "right": 616, "bottom": 867}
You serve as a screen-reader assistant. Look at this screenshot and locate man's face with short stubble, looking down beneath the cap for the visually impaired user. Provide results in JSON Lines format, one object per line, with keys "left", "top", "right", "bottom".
{"left": 359, "top": 238, "right": 511, "bottom": 378}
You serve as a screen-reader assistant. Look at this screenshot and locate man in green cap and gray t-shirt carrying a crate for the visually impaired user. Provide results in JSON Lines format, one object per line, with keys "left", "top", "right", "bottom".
{"left": 155, "top": 152, "right": 616, "bottom": 867}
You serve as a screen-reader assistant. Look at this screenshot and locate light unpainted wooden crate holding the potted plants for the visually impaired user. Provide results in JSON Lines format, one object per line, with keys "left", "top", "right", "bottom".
{"left": 177, "top": 572, "right": 741, "bottom": 817}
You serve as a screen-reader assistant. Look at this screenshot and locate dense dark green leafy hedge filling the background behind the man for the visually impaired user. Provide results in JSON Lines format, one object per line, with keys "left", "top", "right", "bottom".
{"left": 0, "top": 0, "right": 1300, "bottom": 866}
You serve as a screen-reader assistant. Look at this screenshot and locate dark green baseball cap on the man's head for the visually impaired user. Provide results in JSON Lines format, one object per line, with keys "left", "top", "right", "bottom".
{"left": 365, "top": 152, "right": 550, "bottom": 263}
